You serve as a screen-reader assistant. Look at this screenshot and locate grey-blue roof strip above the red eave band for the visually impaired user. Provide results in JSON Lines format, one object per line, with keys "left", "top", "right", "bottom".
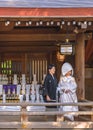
{"left": 0, "top": 0, "right": 93, "bottom": 8}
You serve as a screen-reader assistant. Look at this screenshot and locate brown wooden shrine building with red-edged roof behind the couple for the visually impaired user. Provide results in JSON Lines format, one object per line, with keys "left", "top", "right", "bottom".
{"left": 0, "top": 0, "right": 93, "bottom": 100}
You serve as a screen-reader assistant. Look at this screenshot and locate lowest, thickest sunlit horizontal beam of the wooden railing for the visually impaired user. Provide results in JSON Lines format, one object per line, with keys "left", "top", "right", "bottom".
{"left": 0, "top": 121, "right": 93, "bottom": 129}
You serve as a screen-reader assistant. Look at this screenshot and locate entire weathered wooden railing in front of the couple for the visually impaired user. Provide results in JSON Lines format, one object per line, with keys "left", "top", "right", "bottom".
{"left": 0, "top": 101, "right": 93, "bottom": 130}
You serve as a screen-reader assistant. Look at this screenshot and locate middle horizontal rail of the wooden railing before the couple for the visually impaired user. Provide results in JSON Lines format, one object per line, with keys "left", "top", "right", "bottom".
{"left": 0, "top": 108, "right": 93, "bottom": 116}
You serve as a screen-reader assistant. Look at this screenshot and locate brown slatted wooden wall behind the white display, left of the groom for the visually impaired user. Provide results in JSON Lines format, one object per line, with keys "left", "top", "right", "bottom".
{"left": 0, "top": 53, "right": 47, "bottom": 83}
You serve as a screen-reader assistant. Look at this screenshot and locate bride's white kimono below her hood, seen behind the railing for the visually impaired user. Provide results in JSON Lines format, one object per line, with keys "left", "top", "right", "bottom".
{"left": 58, "top": 76, "right": 78, "bottom": 121}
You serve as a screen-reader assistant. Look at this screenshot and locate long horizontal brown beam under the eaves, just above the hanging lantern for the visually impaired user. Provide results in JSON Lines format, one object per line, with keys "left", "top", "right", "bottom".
{"left": 0, "top": 34, "right": 75, "bottom": 42}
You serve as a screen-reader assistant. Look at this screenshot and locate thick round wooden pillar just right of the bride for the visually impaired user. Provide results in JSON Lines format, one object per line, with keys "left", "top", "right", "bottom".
{"left": 75, "top": 33, "right": 85, "bottom": 100}
